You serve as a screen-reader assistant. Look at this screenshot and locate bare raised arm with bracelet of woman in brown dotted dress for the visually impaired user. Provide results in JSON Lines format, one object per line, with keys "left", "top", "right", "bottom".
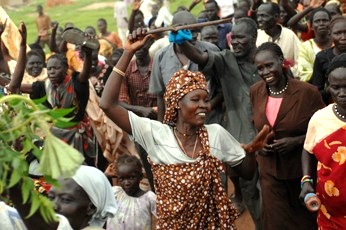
{"left": 100, "top": 29, "right": 152, "bottom": 134}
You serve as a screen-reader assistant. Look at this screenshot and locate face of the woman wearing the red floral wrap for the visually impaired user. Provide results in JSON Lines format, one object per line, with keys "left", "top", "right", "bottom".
{"left": 328, "top": 68, "right": 346, "bottom": 110}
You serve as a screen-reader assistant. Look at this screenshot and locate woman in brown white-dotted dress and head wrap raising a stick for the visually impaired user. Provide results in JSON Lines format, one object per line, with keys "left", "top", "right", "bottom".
{"left": 100, "top": 30, "right": 269, "bottom": 229}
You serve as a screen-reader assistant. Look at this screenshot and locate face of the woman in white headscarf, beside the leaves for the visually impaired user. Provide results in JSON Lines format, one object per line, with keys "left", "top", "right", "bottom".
{"left": 48, "top": 179, "right": 96, "bottom": 229}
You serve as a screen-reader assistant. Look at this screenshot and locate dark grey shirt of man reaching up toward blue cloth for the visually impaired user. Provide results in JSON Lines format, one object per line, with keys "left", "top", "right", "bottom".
{"left": 202, "top": 50, "right": 260, "bottom": 143}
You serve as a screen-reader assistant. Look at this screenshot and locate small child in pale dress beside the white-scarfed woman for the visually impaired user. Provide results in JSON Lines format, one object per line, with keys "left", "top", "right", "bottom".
{"left": 107, "top": 154, "right": 156, "bottom": 230}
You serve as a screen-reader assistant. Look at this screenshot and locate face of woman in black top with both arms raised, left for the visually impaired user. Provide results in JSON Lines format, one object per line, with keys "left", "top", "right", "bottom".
{"left": 47, "top": 58, "right": 67, "bottom": 84}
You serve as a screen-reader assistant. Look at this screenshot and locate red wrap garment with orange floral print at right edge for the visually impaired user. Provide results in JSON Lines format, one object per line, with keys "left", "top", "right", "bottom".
{"left": 312, "top": 126, "right": 346, "bottom": 230}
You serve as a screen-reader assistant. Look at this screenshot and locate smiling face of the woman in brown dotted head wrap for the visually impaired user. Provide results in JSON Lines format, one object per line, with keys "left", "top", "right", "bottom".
{"left": 178, "top": 89, "right": 211, "bottom": 126}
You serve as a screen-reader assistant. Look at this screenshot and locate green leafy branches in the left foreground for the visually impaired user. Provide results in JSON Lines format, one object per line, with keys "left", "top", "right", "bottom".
{"left": 0, "top": 95, "right": 84, "bottom": 222}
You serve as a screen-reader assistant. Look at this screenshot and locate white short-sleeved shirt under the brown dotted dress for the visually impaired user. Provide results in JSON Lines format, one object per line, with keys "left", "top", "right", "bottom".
{"left": 129, "top": 111, "right": 245, "bottom": 167}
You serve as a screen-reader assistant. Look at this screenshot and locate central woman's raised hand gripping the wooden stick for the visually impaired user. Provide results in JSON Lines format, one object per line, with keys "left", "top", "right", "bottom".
{"left": 124, "top": 28, "right": 154, "bottom": 52}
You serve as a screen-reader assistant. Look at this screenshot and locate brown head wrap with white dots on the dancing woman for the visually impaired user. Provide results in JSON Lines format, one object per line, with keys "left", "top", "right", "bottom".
{"left": 163, "top": 69, "right": 208, "bottom": 124}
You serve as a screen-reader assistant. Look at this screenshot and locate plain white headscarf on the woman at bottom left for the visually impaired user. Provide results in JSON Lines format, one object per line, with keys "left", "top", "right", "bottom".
{"left": 72, "top": 165, "right": 116, "bottom": 227}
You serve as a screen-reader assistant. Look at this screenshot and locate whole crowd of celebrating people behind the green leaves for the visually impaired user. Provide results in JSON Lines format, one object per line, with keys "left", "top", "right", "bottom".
{"left": 0, "top": 0, "right": 346, "bottom": 230}
